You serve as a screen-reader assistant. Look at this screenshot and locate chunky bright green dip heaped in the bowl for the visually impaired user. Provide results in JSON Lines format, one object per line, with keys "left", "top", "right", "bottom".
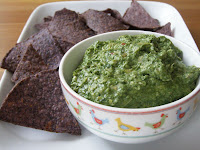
{"left": 71, "top": 34, "right": 200, "bottom": 108}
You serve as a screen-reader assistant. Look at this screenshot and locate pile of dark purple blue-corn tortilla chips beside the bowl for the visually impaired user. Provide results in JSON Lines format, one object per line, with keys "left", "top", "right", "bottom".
{"left": 0, "top": 1, "right": 172, "bottom": 135}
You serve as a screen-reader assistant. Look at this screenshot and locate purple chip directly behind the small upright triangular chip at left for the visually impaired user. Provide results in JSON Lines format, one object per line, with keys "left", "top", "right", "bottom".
{"left": 1, "top": 28, "right": 63, "bottom": 72}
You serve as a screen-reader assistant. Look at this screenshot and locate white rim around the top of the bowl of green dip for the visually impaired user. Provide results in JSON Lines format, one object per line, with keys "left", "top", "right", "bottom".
{"left": 59, "top": 30, "right": 200, "bottom": 114}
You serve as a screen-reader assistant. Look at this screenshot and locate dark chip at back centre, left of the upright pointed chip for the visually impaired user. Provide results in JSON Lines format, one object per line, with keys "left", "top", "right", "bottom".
{"left": 82, "top": 9, "right": 129, "bottom": 34}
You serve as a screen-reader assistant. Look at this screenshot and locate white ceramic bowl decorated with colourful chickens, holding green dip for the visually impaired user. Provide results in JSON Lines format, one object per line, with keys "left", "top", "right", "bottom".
{"left": 59, "top": 30, "right": 200, "bottom": 143}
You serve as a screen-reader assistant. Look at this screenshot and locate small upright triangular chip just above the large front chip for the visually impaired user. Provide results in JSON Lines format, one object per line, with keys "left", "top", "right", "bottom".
{"left": 11, "top": 45, "right": 48, "bottom": 82}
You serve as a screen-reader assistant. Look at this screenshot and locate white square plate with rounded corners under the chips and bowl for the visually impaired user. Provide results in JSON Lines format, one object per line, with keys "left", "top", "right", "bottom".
{"left": 0, "top": 1, "right": 200, "bottom": 150}
